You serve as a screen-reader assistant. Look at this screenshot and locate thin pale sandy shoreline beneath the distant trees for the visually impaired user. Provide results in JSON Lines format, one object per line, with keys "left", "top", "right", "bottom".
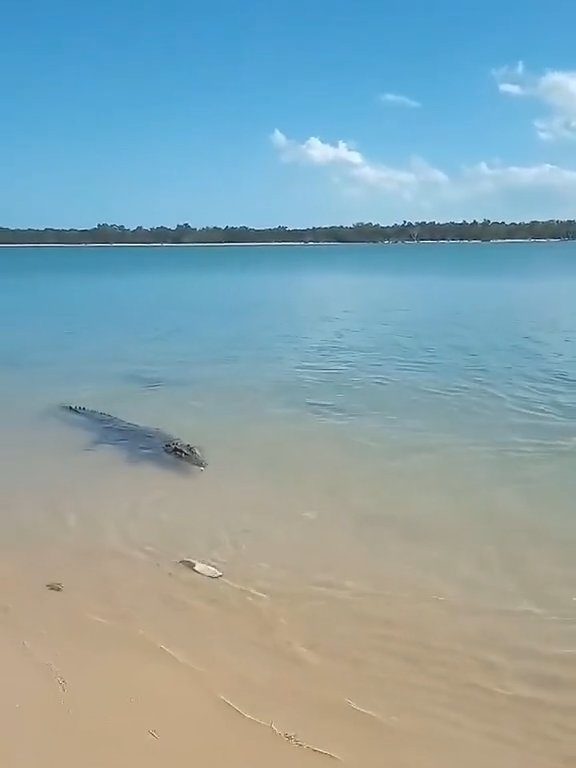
{"left": 0, "top": 237, "right": 574, "bottom": 248}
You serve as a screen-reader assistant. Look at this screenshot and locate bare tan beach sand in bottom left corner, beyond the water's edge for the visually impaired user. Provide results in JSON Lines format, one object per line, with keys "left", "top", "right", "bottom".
{"left": 0, "top": 552, "right": 329, "bottom": 768}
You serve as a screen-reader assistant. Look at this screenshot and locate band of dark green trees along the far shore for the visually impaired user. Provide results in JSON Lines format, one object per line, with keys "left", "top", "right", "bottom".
{"left": 0, "top": 219, "right": 576, "bottom": 245}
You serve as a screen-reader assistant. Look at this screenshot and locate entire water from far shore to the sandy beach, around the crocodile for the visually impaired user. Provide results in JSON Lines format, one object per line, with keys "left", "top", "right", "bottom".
{"left": 0, "top": 243, "right": 576, "bottom": 768}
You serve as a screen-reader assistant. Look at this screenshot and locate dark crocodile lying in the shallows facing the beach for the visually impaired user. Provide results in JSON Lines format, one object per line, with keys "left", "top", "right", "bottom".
{"left": 61, "top": 405, "right": 207, "bottom": 470}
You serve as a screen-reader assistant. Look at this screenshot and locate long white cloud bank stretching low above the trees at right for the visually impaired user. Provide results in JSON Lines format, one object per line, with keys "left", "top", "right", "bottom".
{"left": 270, "top": 130, "right": 576, "bottom": 207}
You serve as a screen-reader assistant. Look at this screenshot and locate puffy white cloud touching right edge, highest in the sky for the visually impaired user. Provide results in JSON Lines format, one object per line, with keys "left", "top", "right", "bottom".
{"left": 493, "top": 62, "right": 576, "bottom": 141}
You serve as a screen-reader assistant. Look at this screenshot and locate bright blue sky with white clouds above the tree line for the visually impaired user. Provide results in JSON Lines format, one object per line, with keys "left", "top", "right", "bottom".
{"left": 0, "top": 0, "right": 576, "bottom": 227}
